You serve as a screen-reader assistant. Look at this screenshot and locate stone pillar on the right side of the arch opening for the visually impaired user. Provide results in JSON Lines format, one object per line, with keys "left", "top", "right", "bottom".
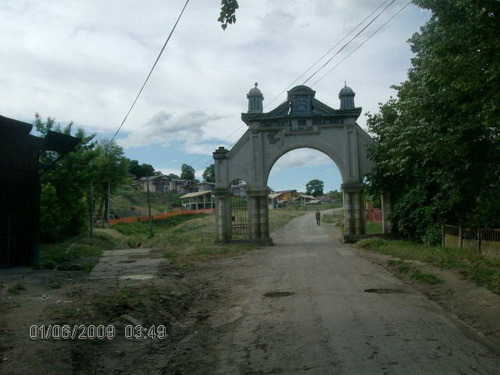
{"left": 342, "top": 183, "right": 365, "bottom": 236}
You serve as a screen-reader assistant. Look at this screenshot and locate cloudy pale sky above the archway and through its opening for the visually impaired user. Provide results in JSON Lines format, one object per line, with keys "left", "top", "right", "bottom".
{"left": 0, "top": 0, "right": 429, "bottom": 191}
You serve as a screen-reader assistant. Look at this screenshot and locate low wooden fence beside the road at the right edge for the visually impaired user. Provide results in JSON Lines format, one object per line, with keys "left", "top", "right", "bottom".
{"left": 442, "top": 225, "right": 500, "bottom": 256}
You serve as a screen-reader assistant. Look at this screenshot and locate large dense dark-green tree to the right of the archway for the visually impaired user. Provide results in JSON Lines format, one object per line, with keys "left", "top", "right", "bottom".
{"left": 368, "top": 0, "right": 500, "bottom": 244}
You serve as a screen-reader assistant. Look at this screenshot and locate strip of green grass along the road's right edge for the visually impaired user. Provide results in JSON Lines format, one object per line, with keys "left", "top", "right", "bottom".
{"left": 358, "top": 238, "right": 500, "bottom": 294}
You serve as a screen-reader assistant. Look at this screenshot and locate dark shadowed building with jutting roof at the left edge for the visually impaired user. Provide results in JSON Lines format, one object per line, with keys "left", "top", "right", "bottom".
{"left": 0, "top": 116, "right": 80, "bottom": 267}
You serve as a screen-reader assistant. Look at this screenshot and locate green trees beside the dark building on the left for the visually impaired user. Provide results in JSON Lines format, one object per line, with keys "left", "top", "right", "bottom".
{"left": 34, "top": 113, "right": 128, "bottom": 242}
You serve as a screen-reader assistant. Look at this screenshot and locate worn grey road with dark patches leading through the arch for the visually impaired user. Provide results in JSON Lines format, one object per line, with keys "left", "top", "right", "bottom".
{"left": 197, "top": 214, "right": 500, "bottom": 375}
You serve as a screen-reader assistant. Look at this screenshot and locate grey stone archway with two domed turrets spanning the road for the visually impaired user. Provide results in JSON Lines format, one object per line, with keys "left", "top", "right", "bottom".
{"left": 213, "top": 84, "right": 380, "bottom": 242}
